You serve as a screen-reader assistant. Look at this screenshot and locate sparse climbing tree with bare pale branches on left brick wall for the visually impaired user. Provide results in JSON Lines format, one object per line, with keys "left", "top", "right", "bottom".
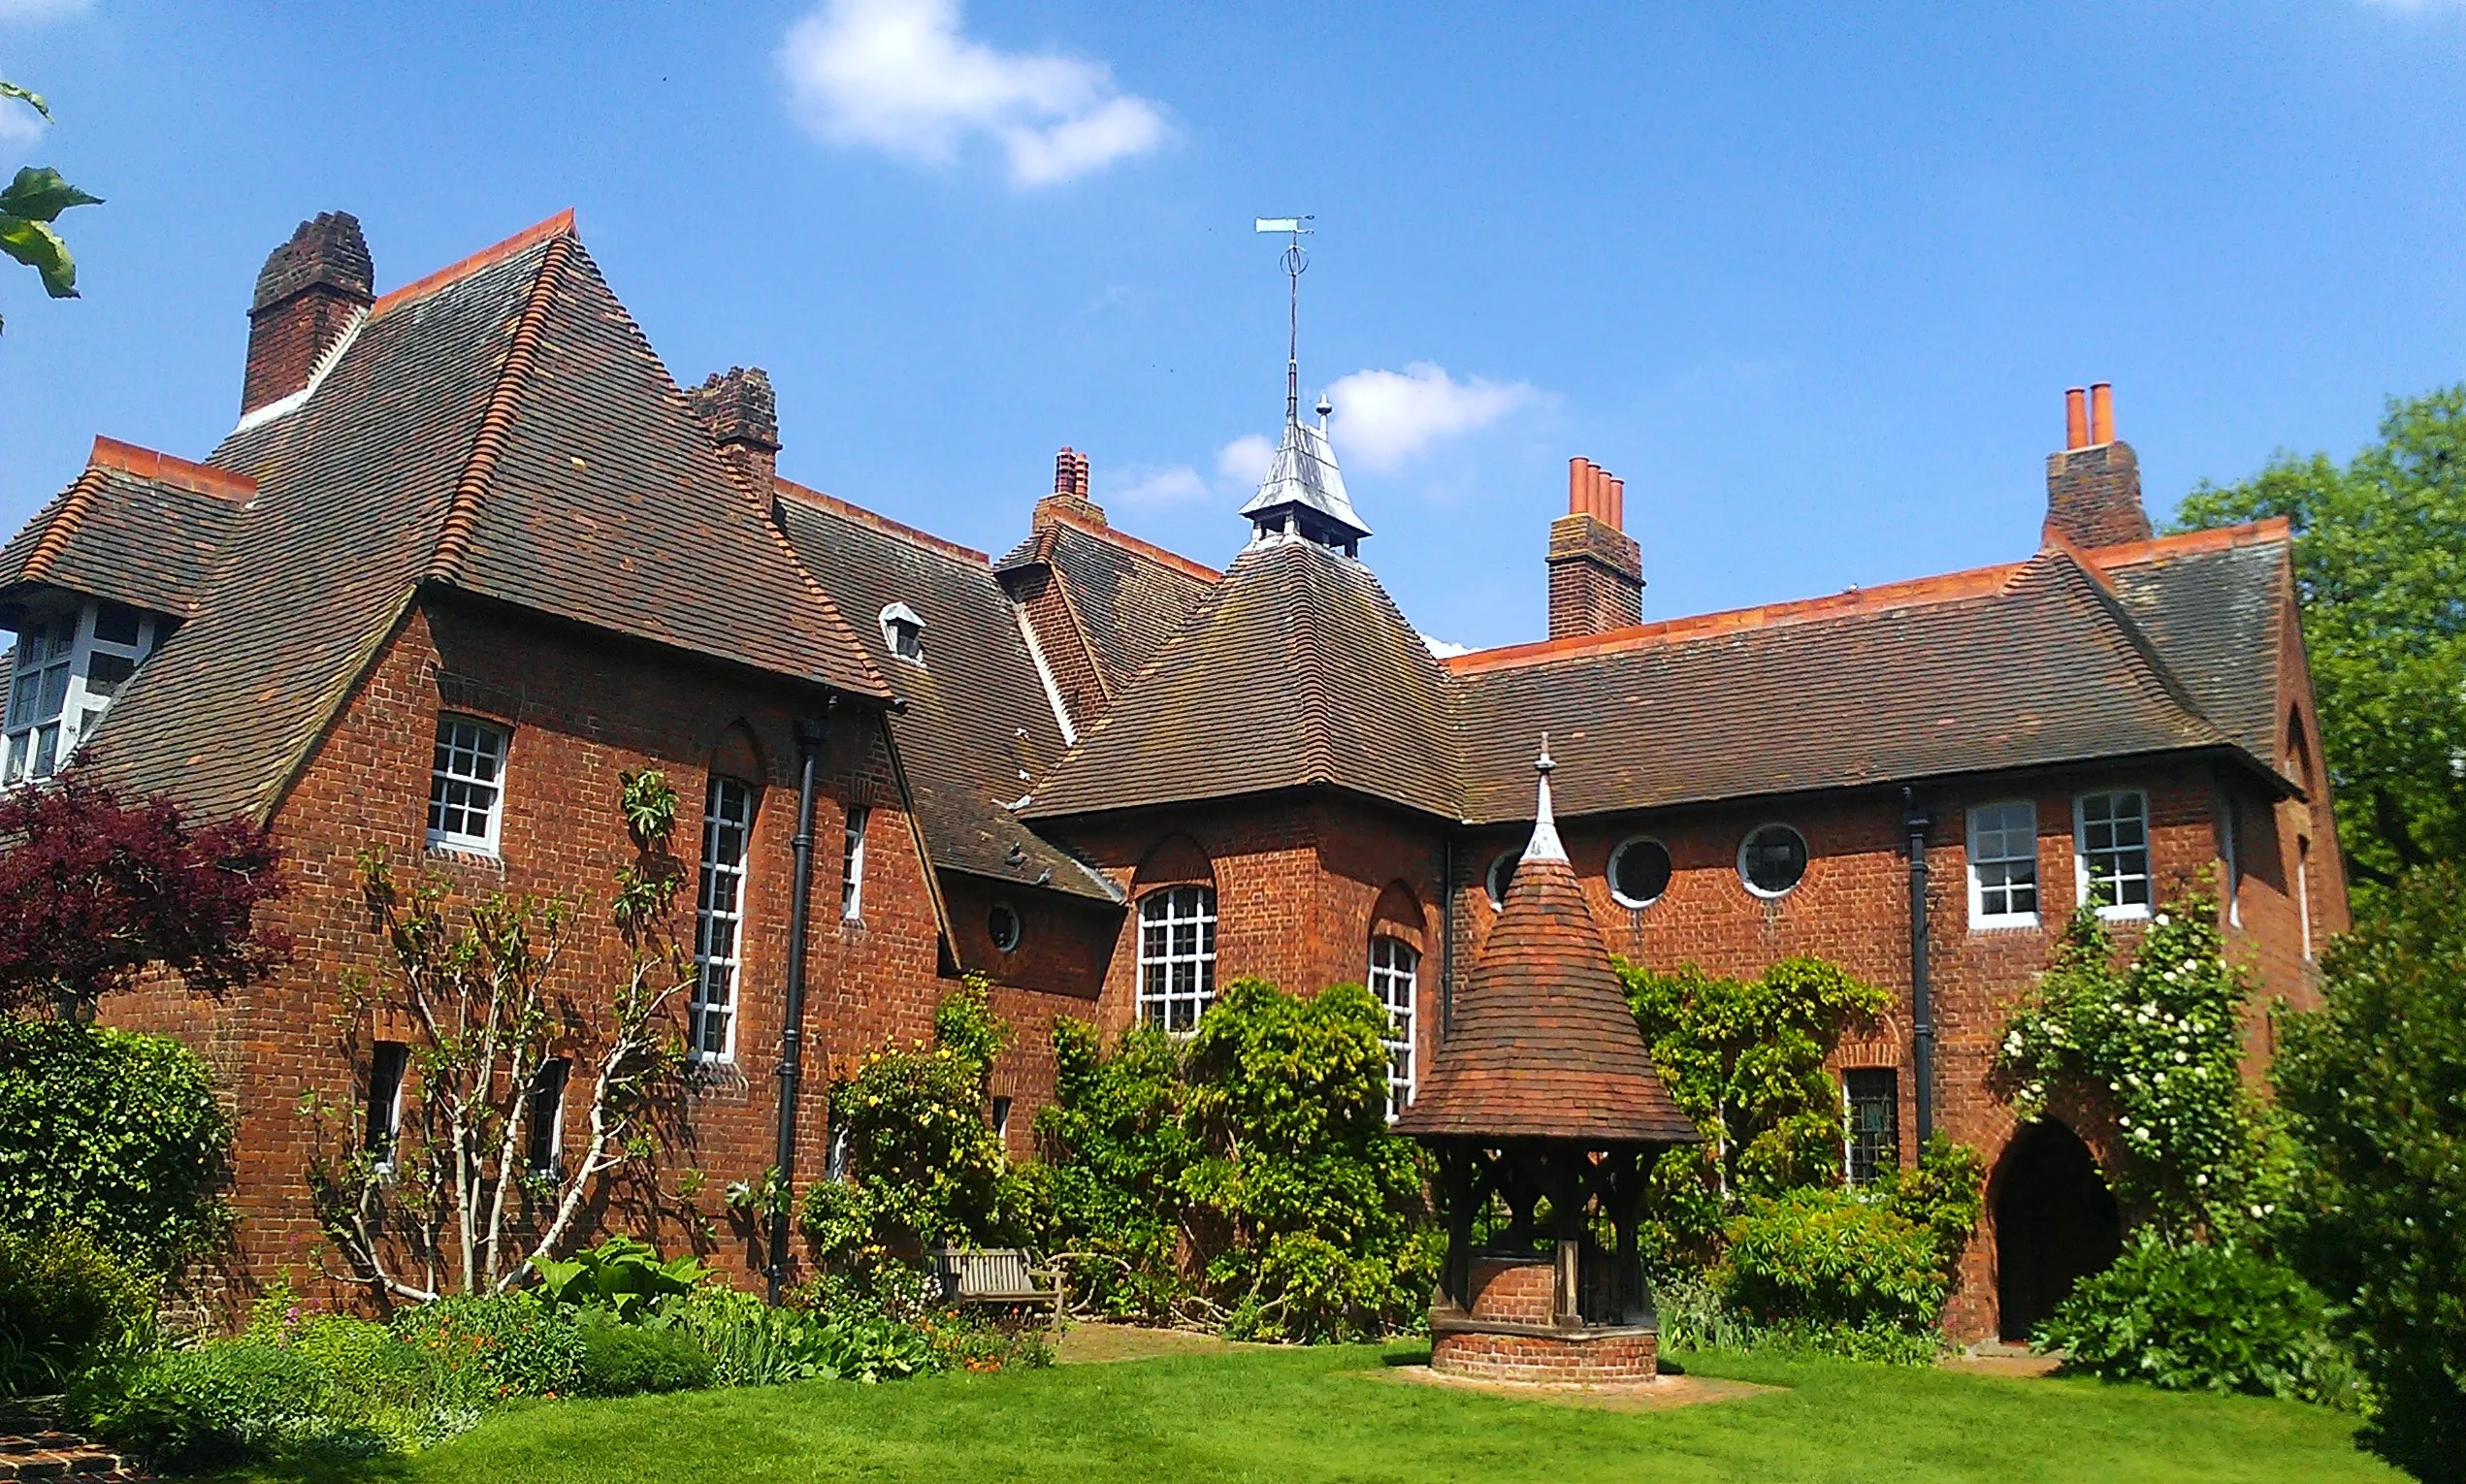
{"left": 301, "top": 771, "right": 696, "bottom": 1299}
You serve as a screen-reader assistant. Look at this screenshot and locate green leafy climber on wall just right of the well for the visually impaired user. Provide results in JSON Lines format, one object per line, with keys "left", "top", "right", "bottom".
{"left": 1618, "top": 956, "right": 1889, "bottom": 1262}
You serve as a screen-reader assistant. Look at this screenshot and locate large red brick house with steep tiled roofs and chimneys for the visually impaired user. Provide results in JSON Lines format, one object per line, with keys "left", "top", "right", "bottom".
{"left": 0, "top": 214, "right": 2345, "bottom": 1337}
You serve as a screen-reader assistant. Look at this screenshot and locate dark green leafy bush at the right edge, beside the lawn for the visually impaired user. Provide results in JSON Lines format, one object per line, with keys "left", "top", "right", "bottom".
{"left": 2271, "top": 865, "right": 2466, "bottom": 1481}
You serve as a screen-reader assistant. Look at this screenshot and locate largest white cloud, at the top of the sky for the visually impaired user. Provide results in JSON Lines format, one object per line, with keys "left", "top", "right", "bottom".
{"left": 789, "top": 0, "right": 1166, "bottom": 190}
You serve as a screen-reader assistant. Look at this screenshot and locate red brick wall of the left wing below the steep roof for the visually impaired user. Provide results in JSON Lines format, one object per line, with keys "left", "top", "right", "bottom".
{"left": 111, "top": 594, "right": 961, "bottom": 1292}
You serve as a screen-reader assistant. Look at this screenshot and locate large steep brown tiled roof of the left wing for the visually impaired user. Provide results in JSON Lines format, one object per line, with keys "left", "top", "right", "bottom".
{"left": 70, "top": 214, "right": 888, "bottom": 814}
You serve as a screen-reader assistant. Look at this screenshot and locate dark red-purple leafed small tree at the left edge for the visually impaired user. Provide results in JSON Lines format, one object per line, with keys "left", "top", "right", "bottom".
{"left": 0, "top": 774, "right": 291, "bottom": 1016}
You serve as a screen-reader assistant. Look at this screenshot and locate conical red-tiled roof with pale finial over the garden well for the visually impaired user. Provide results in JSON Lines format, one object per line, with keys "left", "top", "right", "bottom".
{"left": 1396, "top": 752, "right": 1697, "bottom": 1144}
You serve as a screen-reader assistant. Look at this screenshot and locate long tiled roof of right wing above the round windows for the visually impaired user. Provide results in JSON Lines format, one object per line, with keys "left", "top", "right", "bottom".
{"left": 1447, "top": 547, "right": 2232, "bottom": 823}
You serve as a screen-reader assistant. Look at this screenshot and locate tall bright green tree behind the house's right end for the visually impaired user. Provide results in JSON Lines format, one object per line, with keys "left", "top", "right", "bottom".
{"left": 2178, "top": 384, "right": 2466, "bottom": 885}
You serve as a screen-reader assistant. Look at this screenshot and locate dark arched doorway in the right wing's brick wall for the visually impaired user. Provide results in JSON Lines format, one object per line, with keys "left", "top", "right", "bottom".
{"left": 1995, "top": 1119, "right": 2124, "bottom": 1341}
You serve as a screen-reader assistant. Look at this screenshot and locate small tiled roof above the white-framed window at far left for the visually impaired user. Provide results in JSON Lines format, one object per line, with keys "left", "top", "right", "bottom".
{"left": 0, "top": 438, "right": 256, "bottom": 619}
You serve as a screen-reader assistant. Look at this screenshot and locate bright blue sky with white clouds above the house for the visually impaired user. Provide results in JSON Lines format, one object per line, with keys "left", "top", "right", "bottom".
{"left": 0, "top": 0, "right": 2466, "bottom": 643}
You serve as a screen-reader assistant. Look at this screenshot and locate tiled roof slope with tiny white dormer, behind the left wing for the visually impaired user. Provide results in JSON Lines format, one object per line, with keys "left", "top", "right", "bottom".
{"left": 777, "top": 481, "right": 1119, "bottom": 902}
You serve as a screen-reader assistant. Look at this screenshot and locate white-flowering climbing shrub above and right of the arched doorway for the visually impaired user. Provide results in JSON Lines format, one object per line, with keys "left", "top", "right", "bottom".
{"left": 2000, "top": 895, "right": 2281, "bottom": 1238}
